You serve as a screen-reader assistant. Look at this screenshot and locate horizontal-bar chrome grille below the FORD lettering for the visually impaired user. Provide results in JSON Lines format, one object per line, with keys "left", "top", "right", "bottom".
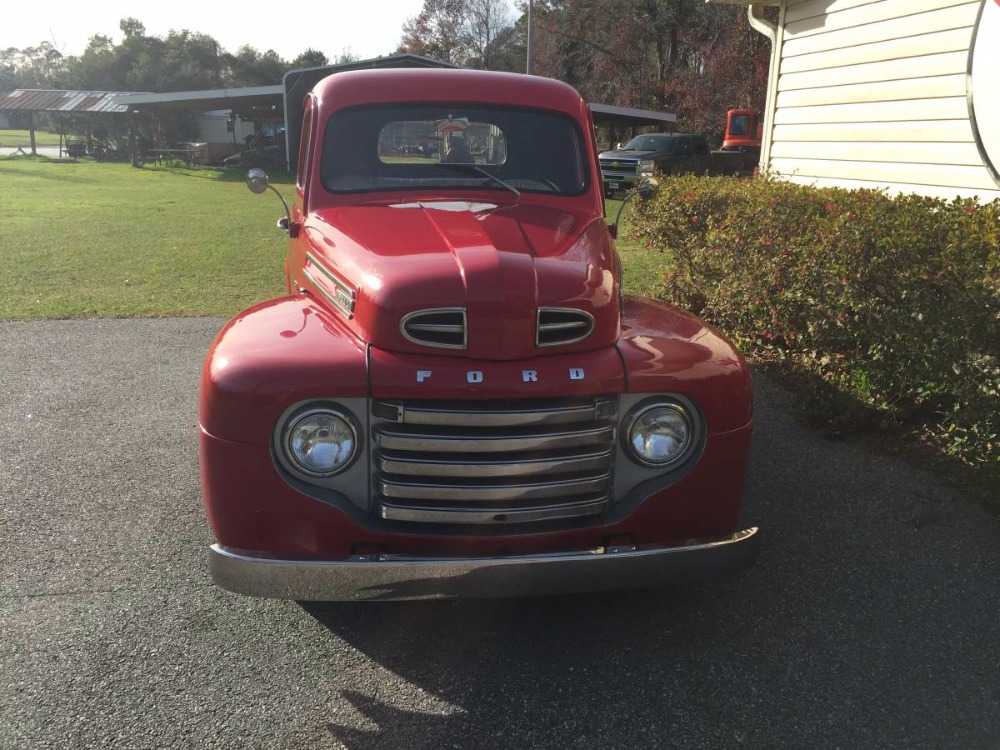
{"left": 372, "top": 398, "right": 617, "bottom": 525}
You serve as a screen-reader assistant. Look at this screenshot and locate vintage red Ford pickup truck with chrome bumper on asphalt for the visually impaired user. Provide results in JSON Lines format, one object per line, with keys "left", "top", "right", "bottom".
{"left": 199, "top": 69, "right": 759, "bottom": 600}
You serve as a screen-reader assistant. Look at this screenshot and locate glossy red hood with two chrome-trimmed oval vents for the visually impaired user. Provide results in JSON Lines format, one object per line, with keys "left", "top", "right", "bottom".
{"left": 291, "top": 200, "right": 620, "bottom": 360}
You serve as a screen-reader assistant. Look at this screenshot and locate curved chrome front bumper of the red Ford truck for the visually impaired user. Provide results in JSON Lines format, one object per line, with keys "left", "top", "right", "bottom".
{"left": 209, "top": 527, "right": 760, "bottom": 601}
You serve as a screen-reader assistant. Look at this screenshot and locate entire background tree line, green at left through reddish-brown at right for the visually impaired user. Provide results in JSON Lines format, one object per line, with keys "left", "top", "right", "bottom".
{"left": 0, "top": 0, "right": 769, "bottom": 144}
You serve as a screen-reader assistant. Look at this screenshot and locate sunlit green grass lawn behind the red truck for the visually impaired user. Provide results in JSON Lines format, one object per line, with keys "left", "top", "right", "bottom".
{"left": 0, "top": 159, "right": 663, "bottom": 318}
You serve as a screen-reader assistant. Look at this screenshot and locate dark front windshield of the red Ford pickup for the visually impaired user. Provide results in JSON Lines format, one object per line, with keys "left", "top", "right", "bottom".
{"left": 322, "top": 104, "right": 588, "bottom": 195}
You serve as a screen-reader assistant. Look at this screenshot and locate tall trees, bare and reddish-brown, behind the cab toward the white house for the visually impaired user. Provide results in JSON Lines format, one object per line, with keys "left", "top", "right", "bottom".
{"left": 399, "top": 0, "right": 776, "bottom": 139}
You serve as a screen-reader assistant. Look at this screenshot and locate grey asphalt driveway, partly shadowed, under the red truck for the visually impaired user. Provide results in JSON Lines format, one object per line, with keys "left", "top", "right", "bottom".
{"left": 0, "top": 319, "right": 1000, "bottom": 750}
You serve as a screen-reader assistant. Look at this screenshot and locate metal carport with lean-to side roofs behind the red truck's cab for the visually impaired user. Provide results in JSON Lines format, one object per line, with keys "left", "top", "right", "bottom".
{"left": 116, "top": 54, "right": 677, "bottom": 170}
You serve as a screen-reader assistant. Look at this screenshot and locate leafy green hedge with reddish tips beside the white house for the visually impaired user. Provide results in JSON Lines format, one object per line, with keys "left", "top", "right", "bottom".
{"left": 629, "top": 176, "right": 1000, "bottom": 478}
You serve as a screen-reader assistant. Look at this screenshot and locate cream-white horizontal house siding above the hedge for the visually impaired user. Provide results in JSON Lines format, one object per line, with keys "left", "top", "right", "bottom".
{"left": 769, "top": 0, "right": 1000, "bottom": 200}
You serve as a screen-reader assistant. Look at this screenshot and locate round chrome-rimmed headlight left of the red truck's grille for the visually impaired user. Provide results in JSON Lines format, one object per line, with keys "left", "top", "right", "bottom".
{"left": 284, "top": 409, "right": 358, "bottom": 477}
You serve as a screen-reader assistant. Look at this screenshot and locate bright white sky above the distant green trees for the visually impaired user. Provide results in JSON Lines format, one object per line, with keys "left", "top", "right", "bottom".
{"left": 0, "top": 0, "right": 434, "bottom": 61}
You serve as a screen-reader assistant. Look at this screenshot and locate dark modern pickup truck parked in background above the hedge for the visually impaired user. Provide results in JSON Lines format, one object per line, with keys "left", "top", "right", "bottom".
{"left": 600, "top": 133, "right": 756, "bottom": 198}
